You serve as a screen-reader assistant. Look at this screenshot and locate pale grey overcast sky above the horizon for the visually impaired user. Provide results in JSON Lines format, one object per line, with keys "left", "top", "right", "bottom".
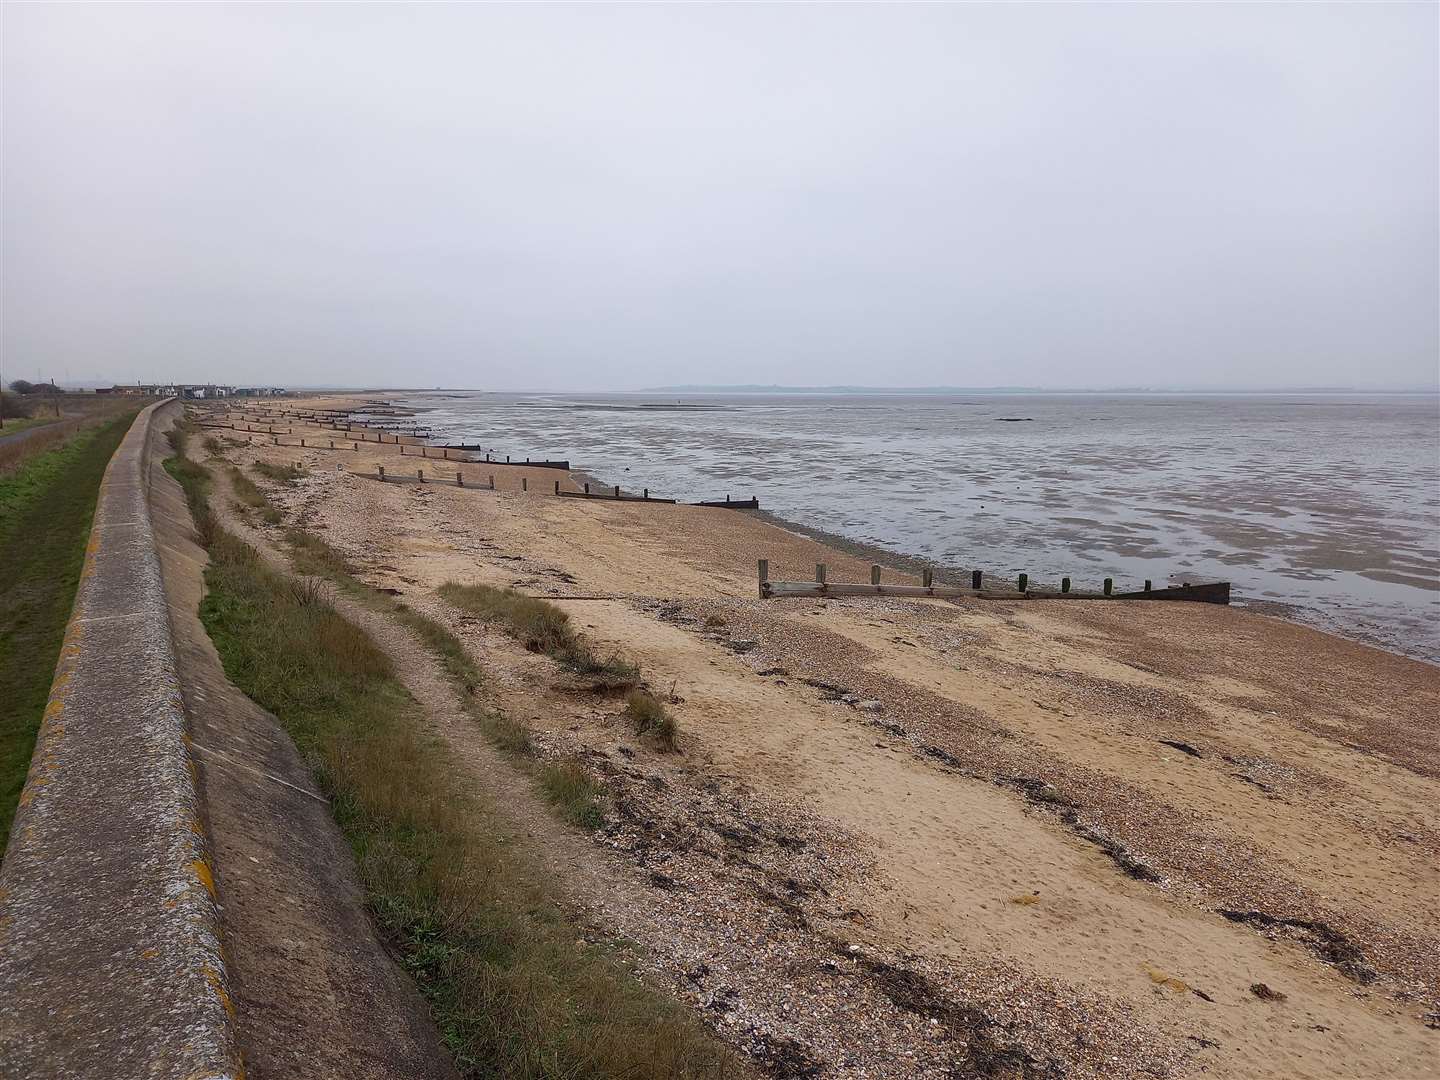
{"left": 3, "top": 3, "right": 1440, "bottom": 390}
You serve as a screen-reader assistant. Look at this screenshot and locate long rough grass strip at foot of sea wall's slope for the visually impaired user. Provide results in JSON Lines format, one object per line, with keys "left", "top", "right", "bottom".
{"left": 171, "top": 446, "right": 736, "bottom": 1080}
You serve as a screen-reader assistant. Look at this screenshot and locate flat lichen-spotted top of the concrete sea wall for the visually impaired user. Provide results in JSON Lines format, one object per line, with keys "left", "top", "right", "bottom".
{"left": 0, "top": 406, "right": 242, "bottom": 1080}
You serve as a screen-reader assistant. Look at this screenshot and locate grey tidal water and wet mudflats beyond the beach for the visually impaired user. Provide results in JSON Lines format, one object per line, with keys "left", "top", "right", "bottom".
{"left": 383, "top": 393, "right": 1440, "bottom": 660}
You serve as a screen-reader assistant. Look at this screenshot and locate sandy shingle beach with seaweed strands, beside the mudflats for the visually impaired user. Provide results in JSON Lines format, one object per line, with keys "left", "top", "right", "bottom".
{"left": 199, "top": 399, "right": 1440, "bottom": 1079}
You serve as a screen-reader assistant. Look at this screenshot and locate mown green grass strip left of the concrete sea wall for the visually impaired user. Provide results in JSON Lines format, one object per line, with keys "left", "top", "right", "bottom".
{"left": 0, "top": 409, "right": 138, "bottom": 851}
